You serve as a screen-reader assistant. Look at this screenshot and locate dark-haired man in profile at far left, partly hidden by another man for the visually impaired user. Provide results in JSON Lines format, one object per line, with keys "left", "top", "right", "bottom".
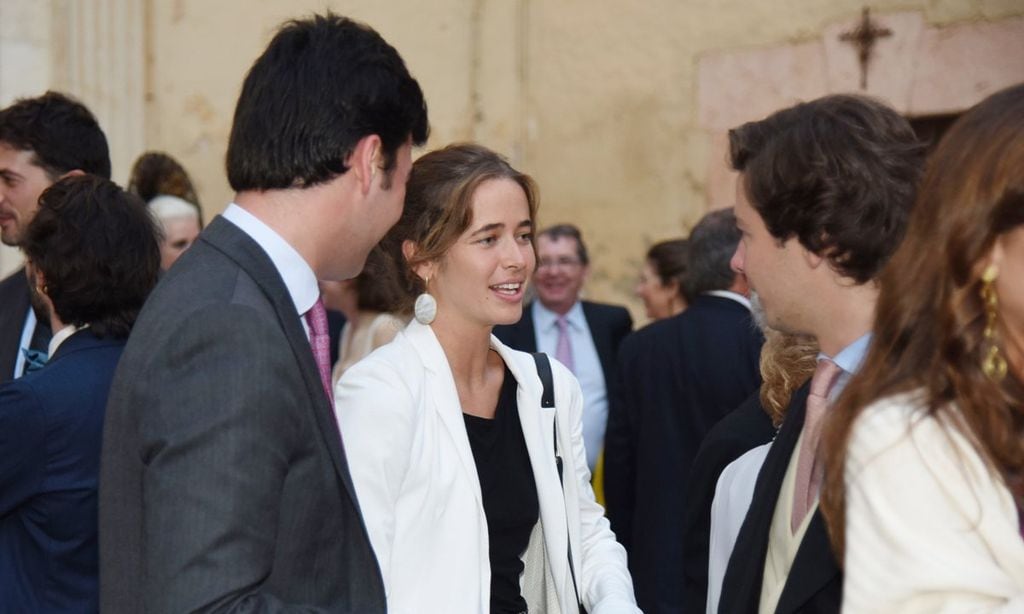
{"left": 0, "top": 92, "right": 111, "bottom": 384}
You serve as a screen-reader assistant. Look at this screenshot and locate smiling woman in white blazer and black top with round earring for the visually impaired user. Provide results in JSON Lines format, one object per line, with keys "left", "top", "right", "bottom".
{"left": 336, "top": 145, "right": 639, "bottom": 614}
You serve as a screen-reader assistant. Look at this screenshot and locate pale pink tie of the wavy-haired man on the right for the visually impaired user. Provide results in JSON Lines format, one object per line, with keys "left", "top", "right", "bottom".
{"left": 790, "top": 358, "right": 843, "bottom": 533}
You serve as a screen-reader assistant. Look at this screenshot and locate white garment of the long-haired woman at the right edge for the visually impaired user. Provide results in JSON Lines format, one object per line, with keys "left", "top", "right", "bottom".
{"left": 843, "top": 394, "right": 1024, "bottom": 614}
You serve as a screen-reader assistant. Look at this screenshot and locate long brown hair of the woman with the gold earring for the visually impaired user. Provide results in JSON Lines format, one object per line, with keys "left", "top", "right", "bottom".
{"left": 821, "top": 85, "right": 1024, "bottom": 561}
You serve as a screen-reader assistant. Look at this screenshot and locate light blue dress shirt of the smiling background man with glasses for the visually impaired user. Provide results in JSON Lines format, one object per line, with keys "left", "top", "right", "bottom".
{"left": 532, "top": 301, "right": 608, "bottom": 473}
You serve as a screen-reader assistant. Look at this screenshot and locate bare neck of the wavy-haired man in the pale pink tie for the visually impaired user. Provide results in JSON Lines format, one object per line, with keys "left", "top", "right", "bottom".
{"left": 813, "top": 282, "right": 879, "bottom": 357}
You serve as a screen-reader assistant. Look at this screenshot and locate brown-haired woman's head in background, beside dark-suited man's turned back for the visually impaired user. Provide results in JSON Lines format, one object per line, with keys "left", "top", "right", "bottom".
{"left": 636, "top": 238, "right": 689, "bottom": 320}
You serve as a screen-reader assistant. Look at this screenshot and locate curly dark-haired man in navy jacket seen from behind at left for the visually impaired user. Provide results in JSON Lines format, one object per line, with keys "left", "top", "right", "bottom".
{"left": 0, "top": 175, "right": 160, "bottom": 612}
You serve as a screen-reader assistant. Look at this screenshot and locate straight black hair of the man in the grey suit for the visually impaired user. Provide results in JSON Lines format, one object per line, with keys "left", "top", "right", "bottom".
{"left": 227, "top": 12, "right": 428, "bottom": 191}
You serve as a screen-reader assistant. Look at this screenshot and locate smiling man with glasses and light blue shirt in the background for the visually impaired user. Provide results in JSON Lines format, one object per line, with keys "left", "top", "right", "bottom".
{"left": 495, "top": 224, "right": 633, "bottom": 472}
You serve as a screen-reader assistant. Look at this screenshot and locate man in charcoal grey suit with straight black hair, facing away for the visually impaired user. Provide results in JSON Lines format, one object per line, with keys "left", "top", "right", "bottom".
{"left": 99, "top": 14, "right": 428, "bottom": 614}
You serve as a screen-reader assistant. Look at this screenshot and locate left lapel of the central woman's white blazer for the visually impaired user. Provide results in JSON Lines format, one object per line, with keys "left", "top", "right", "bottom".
{"left": 406, "top": 319, "right": 483, "bottom": 505}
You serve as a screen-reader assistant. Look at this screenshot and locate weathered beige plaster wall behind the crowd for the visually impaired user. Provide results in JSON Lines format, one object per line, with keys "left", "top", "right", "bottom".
{"left": 0, "top": 0, "right": 1024, "bottom": 316}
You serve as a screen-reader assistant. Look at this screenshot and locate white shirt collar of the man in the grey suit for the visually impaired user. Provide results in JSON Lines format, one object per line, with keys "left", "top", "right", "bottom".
{"left": 221, "top": 203, "right": 319, "bottom": 315}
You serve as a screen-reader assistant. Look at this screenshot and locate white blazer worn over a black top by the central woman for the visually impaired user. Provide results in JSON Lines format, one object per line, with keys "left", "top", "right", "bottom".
{"left": 335, "top": 320, "right": 639, "bottom": 614}
